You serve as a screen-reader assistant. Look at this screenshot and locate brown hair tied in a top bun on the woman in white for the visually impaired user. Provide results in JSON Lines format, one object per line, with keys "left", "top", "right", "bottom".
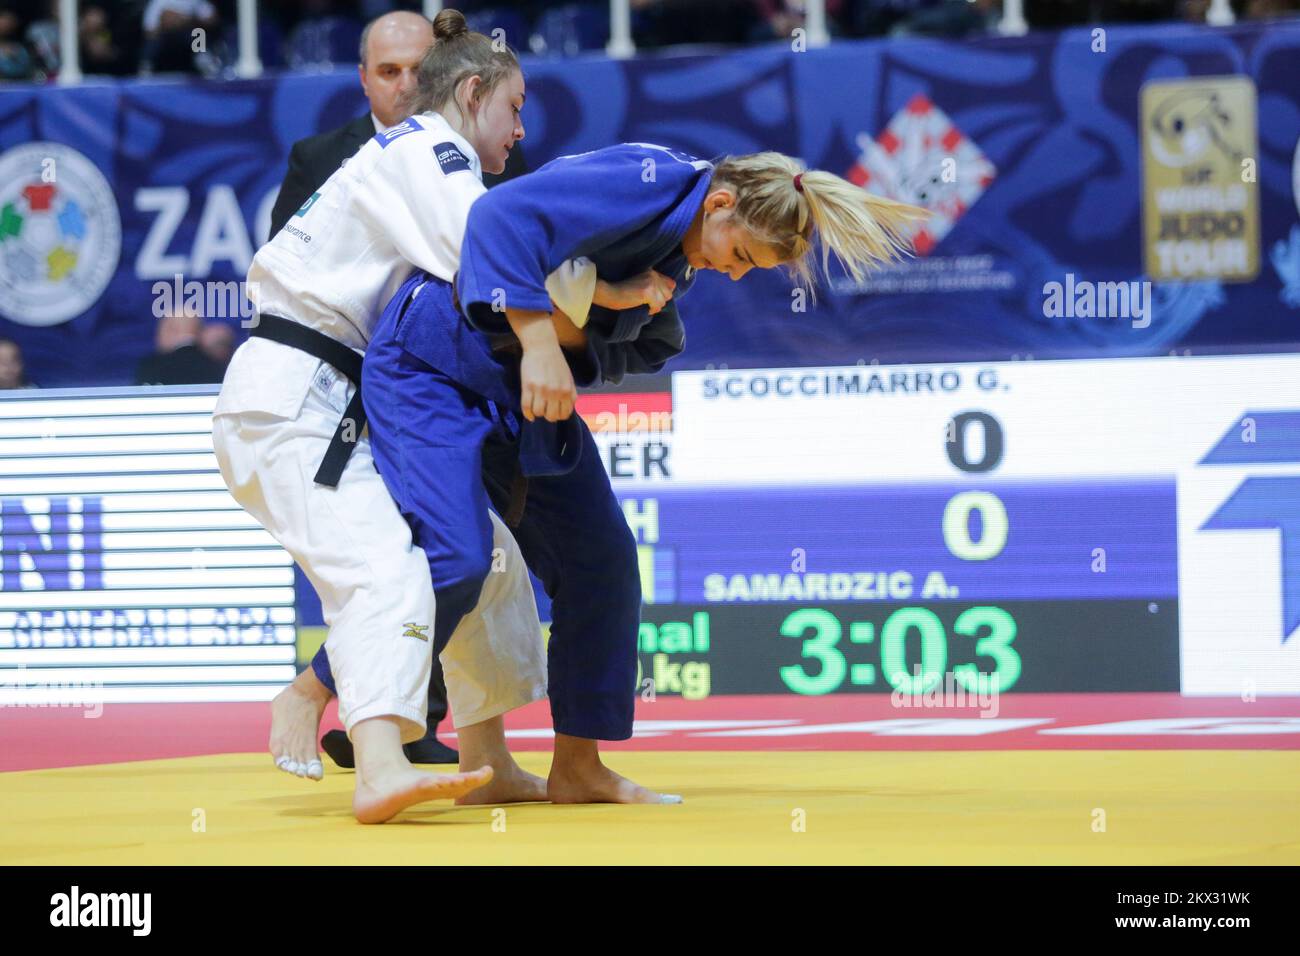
{"left": 404, "top": 8, "right": 519, "bottom": 123}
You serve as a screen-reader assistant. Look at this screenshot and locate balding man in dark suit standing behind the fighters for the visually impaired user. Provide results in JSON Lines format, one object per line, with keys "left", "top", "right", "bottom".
{"left": 270, "top": 10, "right": 525, "bottom": 767}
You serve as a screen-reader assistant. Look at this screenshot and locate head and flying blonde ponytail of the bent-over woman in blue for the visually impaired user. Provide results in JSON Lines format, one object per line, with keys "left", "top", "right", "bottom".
{"left": 710, "top": 152, "right": 930, "bottom": 293}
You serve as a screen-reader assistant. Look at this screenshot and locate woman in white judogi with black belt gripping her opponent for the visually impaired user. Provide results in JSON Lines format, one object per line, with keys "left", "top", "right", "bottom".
{"left": 213, "top": 24, "right": 574, "bottom": 822}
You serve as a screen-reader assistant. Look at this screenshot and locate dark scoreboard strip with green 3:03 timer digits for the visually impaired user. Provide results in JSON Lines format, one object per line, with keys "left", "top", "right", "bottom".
{"left": 637, "top": 600, "right": 1179, "bottom": 706}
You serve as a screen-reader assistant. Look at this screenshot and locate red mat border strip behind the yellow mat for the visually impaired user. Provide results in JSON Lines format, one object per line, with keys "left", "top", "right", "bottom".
{"left": 0, "top": 693, "right": 1300, "bottom": 770}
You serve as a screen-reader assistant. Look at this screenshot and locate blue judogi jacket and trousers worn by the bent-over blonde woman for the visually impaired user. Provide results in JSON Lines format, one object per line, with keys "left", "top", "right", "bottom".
{"left": 313, "top": 144, "right": 711, "bottom": 740}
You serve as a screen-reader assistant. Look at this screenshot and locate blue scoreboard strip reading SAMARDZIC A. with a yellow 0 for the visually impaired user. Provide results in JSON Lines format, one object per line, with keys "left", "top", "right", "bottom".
{"left": 620, "top": 479, "right": 1178, "bottom": 604}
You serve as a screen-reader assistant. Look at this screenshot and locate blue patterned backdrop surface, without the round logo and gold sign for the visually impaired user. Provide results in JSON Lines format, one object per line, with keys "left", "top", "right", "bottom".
{"left": 0, "top": 23, "right": 1300, "bottom": 385}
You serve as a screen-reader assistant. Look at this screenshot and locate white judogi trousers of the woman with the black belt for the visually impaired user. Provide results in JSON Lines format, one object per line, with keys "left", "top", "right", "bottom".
{"left": 212, "top": 339, "right": 546, "bottom": 743}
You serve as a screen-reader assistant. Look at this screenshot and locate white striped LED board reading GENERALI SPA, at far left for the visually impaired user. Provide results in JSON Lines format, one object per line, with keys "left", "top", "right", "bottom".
{"left": 0, "top": 388, "right": 296, "bottom": 705}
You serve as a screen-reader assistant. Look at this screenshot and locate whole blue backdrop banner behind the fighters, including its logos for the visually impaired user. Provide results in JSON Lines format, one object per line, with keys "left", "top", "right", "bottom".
{"left": 0, "top": 23, "right": 1300, "bottom": 385}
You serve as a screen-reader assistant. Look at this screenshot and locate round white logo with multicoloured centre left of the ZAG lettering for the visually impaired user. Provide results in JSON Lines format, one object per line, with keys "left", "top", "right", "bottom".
{"left": 0, "top": 143, "right": 122, "bottom": 325}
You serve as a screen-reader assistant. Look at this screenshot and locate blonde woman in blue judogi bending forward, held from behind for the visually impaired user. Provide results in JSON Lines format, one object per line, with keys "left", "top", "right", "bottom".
{"left": 314, "top": 143, "right": 925, "bottom": 803}
